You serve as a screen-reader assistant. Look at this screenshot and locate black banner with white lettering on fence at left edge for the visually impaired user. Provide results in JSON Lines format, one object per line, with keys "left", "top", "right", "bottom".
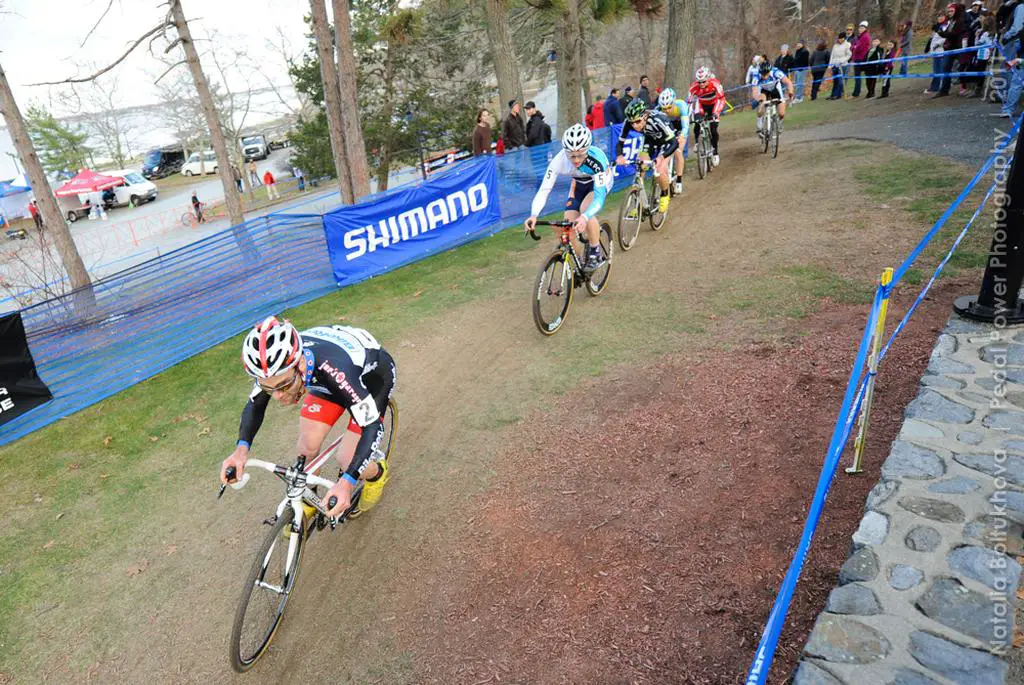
{"left": 0, "top": 311, "right": 53, "bottom": 426}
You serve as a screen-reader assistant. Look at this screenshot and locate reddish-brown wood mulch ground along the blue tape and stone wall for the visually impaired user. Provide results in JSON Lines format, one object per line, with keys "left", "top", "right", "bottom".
{"left": 407, "top": 280, "right": 974, "bottom": 685}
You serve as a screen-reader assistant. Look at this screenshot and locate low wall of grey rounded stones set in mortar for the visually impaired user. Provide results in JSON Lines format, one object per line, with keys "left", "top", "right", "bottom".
{"left": 794, "top": 316, "right": 1024, "bottom": 685}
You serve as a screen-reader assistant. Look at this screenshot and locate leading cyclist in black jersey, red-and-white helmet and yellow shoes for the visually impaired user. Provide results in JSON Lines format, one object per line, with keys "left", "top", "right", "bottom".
{"left": 220, "top": 316, "right": 395, "bottom": 516}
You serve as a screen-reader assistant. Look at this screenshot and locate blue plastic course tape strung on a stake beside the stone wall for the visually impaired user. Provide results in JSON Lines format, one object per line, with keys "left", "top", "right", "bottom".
{"left": 745, "top": 113, "right": 1024, "bottom": 685}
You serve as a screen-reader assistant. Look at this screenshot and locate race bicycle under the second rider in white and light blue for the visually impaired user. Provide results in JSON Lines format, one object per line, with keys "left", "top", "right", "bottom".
{"left": 529, "top": 221, "right": 612, "bottom": 336}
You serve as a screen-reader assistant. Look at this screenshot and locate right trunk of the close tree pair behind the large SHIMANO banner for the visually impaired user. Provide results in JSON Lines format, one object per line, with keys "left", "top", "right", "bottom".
{"left": 334, "top": 0, "right": 370, "bottom": 199}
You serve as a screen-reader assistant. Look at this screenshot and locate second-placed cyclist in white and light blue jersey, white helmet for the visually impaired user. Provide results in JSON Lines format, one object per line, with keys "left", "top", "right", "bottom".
{"left": 525, "top": 124, "right": 614, "bottom": 271}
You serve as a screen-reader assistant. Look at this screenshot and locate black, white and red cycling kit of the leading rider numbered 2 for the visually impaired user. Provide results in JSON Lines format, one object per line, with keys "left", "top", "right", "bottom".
{"left": 239, "top": 326, "right": 395, "bottom": 482}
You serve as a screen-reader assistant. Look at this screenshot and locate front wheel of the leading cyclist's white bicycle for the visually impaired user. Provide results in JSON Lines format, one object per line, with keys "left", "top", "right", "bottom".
{"left": 230, "top": 507, "right": 303, "bottom": 673}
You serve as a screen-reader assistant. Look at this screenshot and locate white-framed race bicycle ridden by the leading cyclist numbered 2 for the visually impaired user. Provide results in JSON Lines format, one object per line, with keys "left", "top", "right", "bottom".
{"left": 217, "top": 398, "right": 398, "bottom": 673}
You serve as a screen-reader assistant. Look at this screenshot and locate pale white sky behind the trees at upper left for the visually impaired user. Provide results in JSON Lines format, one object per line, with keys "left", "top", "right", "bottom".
{"left": 0, "top": 0, "right": 311, "bottom": 111}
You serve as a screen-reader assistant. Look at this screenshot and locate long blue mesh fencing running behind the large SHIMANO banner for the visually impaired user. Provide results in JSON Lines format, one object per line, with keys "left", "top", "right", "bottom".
{"left": 0, "top": 129, "right": 631, "bottom": 444}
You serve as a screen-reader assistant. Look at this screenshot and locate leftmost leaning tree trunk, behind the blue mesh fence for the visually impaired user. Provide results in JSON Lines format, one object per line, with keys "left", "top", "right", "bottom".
{"left": 0, "top": 60, "right": 95, "bottom": 306}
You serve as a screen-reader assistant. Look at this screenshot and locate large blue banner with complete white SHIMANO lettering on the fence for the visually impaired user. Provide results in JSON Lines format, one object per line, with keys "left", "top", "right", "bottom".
{"left": 324, "top": 155, "right": 501, "bottom": 286}
